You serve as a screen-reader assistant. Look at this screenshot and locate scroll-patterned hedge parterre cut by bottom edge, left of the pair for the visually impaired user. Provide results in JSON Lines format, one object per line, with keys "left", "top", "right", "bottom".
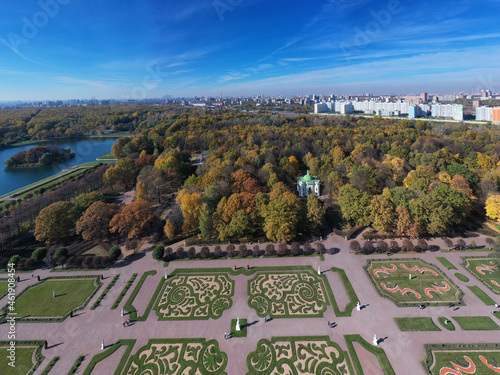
{"left": 125, "top": 339, "right": 227, "bottom": 375}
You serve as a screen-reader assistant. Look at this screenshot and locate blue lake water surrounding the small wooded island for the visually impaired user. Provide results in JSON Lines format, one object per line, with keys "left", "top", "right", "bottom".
{"left": 0, "top": 137, "right": 118, "bottom": 196}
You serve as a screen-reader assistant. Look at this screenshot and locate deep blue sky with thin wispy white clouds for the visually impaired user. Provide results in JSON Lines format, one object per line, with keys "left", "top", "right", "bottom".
{"left": 0, "top": 0, "right": 500, "bottom": 100}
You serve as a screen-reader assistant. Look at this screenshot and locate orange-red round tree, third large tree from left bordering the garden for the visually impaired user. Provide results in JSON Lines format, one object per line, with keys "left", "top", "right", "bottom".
{"left": 109, "top": 200, "right": 153, "bottom": 239}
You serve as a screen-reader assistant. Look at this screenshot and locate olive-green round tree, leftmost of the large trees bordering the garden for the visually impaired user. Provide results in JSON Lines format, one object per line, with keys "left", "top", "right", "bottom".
{"left": 34, "top": 201, "right": 75, "bottom": 243}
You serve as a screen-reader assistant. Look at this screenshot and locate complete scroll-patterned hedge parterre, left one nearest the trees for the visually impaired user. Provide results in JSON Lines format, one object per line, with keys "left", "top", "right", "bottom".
{"left": 155, "top": 273, "right": 234, "bottom": 320}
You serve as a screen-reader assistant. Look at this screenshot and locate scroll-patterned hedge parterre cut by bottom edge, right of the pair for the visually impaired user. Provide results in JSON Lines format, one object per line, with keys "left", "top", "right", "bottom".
{"left": 247, "top": 336, "right": 354, "bottom": 375}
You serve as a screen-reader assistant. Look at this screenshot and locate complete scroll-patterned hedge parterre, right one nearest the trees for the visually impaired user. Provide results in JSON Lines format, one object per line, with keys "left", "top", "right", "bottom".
{"left": 248, "top": 271, "right": 329, "bottom": 318}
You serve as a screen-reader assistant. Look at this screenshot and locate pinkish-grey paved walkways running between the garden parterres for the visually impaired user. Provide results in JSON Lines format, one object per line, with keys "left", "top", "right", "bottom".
{"left": 0, "top": 235, "right": 500, "bottom": 375}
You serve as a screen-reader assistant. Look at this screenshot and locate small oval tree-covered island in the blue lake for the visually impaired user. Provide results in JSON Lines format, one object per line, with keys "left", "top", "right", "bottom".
{"left": 4, "top": 146, "right": 76, "bottom": 168}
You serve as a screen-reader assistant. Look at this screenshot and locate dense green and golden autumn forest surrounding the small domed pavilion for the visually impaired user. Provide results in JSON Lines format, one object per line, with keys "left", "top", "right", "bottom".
{"left": 0, "top": 108, "right": 500, "bottom": 251}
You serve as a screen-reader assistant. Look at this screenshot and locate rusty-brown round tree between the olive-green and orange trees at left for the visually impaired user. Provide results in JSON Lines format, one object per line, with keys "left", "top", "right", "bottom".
{"left": 76, "top": 201, "right": 119, "bottom": 240}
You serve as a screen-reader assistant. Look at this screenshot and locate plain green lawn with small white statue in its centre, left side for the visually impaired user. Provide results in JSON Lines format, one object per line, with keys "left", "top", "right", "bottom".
{"left": 15, "top": 278, "right": 97, "bottom": 317}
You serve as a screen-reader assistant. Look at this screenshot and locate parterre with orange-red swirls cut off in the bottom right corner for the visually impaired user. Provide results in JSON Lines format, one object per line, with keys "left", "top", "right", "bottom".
{"left": 423, "top": 344, "right": 500, "bottom": 375}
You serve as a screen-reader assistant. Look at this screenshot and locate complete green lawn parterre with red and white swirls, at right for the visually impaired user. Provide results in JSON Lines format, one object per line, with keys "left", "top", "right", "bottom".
{"left": 365, "top": 258, "right": 463, "bottom": 306}
